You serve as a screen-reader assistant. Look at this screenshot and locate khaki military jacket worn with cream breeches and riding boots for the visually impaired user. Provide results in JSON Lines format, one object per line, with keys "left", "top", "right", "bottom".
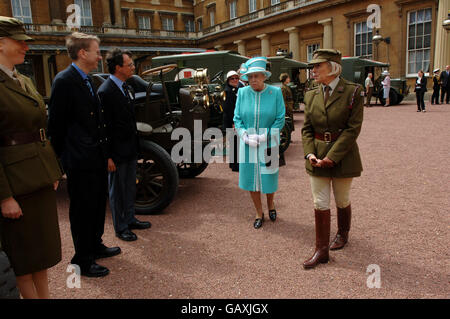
{"left": 302, "top": 79, "right": 364, "bottom": 178}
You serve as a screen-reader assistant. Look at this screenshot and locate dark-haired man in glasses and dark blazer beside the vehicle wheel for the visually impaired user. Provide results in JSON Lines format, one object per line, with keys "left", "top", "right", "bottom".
{"left": 98, "top": 48, "right": 151, "bottom": 241}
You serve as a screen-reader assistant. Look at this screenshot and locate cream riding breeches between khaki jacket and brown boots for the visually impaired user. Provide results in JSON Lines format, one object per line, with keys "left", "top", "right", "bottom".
{"left": 310, "top": 176, "right": 353, "bottom": 210}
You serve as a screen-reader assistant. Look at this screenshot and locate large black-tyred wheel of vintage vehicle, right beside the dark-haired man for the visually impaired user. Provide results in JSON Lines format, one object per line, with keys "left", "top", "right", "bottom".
{"left": 135, "top": 140, "right": 179, "bottom": 215}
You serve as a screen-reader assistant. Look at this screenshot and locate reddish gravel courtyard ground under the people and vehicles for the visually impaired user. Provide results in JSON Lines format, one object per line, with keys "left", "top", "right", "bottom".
{"left": 49, "top": 102, "right": 450, "bottom": 299}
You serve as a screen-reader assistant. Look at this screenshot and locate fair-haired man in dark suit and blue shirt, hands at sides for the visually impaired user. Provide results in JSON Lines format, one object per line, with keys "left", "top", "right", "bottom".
{"left": 48, "top": 32, "right": 120, "bottom": 277}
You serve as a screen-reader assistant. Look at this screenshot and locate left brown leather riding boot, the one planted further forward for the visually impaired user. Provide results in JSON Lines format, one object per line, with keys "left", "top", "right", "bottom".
{"left": 303, "top": 209, "right": 330, "bottom": 269}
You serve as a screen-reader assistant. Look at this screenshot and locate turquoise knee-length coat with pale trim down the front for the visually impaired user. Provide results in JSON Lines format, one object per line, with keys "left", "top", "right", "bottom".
{"left": 233, "top": 84, "right": 285, "bottom": 194}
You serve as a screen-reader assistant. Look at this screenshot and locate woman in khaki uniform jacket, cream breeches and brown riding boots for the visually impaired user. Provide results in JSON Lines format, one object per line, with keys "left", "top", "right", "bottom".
{"left": 302, "top": 49, "right": 364, "bottom": 269}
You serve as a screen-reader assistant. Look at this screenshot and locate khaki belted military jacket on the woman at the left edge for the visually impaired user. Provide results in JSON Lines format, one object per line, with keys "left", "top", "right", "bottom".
{"left": 0, "top": 70, "right": 62, "bottom": 200}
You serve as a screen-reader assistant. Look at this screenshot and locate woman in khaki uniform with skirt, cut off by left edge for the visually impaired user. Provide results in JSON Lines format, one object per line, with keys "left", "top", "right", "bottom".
{"left": 0, "top": 17, "right": 61, "bottom": 298}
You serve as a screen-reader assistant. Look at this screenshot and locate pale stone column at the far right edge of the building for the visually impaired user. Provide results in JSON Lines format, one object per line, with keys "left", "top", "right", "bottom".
{"left": 430, "top": 1, "right": 450, "bottom": 73}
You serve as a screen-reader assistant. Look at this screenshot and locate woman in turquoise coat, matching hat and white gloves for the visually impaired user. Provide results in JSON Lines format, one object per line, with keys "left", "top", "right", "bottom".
{"left": 233, "top": 57, "right": 285, "bottom": 228}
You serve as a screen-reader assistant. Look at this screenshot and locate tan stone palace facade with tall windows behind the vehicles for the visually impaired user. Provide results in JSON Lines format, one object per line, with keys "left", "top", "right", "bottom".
{"left": 0, "top": 0, "right": 450, "bottom": 96}
